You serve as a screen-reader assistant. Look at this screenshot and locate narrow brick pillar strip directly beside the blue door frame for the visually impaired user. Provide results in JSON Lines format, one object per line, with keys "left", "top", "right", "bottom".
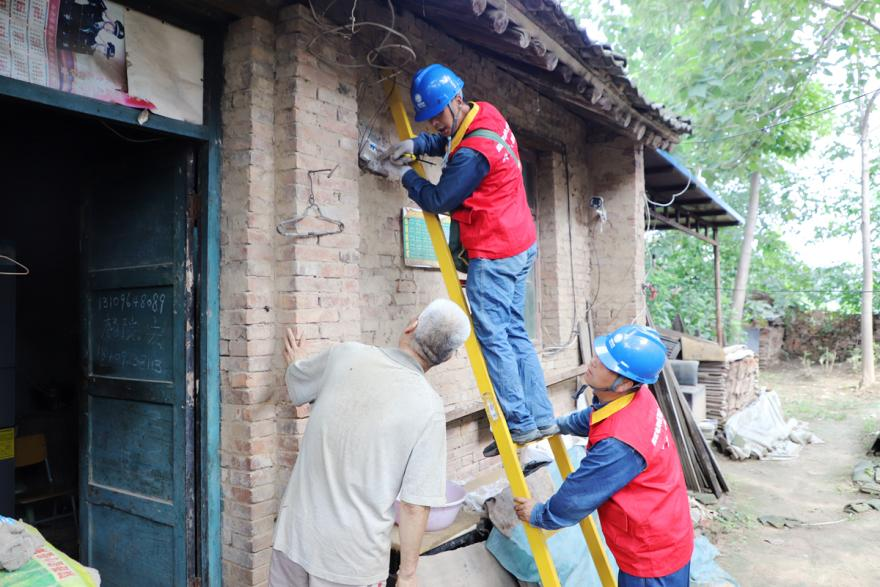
{"left": 220, "top": 14, "right": 279, "bottom": 585}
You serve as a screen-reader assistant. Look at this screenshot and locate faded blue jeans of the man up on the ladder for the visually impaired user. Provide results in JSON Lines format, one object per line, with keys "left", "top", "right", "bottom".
{"left": 467, "top": 244, "right": 555, "bottom": 432}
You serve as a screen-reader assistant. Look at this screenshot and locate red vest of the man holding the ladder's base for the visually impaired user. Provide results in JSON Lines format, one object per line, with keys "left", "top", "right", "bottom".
{"left": 589, "top": 385, "right": 694, "bottom": 577}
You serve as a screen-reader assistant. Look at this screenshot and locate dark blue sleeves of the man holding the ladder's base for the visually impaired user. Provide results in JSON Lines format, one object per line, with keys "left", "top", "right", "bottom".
{"left": 530, "top": 398, "right": 647, "bottom": 530}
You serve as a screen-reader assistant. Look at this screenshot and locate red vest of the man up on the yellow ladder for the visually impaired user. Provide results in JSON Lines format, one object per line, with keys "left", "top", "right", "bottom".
{"left": 449, "top": 102, "right": 537, "bottom": 259}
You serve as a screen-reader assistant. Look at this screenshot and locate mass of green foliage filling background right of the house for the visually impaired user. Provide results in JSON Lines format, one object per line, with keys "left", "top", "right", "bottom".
{"left": 563, "top": 0, "right": 880, "bottom": 340}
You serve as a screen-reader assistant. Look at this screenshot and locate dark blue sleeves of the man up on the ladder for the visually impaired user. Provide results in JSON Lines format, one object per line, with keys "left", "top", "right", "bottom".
{"left": 402, "top": 133, "right": 489, "bottom": 212}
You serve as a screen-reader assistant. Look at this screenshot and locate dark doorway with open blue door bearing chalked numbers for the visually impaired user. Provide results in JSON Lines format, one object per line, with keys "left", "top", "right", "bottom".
{"left": 0, "top": 99, "right": 198, "bottom": 586}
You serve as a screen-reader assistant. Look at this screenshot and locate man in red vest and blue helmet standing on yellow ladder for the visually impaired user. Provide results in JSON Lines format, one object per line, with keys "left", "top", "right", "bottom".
{"left": 386, "top": 63, "right": 558, "bottom": 456}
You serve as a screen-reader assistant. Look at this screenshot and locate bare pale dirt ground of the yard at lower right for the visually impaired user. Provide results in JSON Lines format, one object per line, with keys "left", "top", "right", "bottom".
{"left": 709, "top": 362, "right": 880, "bottom": 587}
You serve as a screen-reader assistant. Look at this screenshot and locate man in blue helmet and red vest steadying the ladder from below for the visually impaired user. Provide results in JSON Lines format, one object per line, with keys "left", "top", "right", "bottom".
{"left": 515, "top": 326, "right": 694, "bottom": 587}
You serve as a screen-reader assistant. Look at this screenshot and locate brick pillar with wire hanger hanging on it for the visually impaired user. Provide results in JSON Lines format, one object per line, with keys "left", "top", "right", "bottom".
{"left": 274, "top": 7, "right": 360, "bottom": 506}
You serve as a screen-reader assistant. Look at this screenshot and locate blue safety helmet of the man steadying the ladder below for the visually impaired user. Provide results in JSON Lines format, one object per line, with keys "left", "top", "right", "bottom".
{"left": 595, "top": 325, "right": 666, "bottom": 387}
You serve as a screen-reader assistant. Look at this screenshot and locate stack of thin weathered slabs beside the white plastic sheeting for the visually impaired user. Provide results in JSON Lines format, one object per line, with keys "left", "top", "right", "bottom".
{"left": 697, "top": 347, "right": 758, "bottom": 422}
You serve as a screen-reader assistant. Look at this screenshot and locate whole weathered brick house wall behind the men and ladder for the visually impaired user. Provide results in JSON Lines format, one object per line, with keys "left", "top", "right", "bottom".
{"left": 221, "top": 1, "right": 643, "bottom": 585}
